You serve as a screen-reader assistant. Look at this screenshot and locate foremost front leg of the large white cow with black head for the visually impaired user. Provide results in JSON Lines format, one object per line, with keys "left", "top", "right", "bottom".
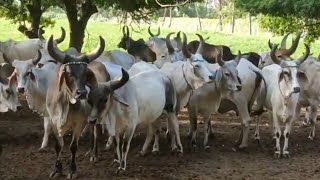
{"left": 116, "top": 128, "right": 135, "bottom": 174}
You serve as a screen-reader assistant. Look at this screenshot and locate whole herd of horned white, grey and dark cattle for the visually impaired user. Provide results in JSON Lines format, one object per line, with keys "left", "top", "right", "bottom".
{"left": 0, "top": 27, "right": 320, "bottom": 178}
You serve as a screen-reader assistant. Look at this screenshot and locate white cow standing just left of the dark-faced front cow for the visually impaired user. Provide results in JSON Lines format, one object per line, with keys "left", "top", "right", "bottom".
{"left": 7, "top": 50, "right": 57, "bottom": 151}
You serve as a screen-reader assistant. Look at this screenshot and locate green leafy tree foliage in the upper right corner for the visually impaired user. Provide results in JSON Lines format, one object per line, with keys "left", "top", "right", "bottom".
{"left": 236, "top": 0, "right": 320, "bottom": 42}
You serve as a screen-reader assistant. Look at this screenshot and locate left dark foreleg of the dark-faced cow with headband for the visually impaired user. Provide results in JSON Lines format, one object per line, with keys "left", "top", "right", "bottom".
{"left": 50, "top": 130, "right": 64, "bottom": 178}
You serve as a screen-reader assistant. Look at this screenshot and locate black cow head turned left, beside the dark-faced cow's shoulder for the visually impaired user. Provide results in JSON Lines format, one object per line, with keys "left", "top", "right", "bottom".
{"left": 88, "top": 69, "right": 129, "bottom": 123}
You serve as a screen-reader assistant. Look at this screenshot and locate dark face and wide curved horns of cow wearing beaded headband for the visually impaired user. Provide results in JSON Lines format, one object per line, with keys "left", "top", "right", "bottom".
{"left": 47, "top": 36, "right": 105, "bottom": 104}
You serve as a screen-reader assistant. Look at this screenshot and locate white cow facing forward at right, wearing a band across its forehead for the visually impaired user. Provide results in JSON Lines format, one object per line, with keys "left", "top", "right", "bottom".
{"left": 257, "top": 44, "right": 310, "bottom": 158}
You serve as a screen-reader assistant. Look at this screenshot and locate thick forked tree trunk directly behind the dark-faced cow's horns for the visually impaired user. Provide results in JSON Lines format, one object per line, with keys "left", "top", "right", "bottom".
{"left": 63, "top": 0, "right": 98, "bottom": 52}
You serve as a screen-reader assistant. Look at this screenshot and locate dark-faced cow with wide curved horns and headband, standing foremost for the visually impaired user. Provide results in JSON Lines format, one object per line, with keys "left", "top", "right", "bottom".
{"left": 46, "top": 35, "right": 107, "bottom": 178}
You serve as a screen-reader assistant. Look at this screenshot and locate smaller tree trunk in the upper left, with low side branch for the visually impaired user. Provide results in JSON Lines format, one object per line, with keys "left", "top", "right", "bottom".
{"left": 18, "top": 0, "right": 43, "bottom": 39}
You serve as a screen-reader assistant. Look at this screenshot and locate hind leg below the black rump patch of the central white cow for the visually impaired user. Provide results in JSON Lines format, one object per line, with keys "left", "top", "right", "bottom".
{"left": 168, "top": 112, "right": 183, "bottom": 153}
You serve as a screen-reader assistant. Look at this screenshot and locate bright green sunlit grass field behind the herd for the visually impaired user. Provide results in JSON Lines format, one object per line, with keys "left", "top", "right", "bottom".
{"left": 0, "top": 19, "right": 320, "bottom": 57}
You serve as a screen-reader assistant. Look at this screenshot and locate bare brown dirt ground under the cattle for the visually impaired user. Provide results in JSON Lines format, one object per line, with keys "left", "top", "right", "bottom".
{"left": 0, "top": 99, "right": 320, "bottom": 180}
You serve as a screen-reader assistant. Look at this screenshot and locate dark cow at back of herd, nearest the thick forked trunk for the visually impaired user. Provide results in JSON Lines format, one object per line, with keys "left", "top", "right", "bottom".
{"left": 118, "top": 26, "right": 156, "bottom": 62}
